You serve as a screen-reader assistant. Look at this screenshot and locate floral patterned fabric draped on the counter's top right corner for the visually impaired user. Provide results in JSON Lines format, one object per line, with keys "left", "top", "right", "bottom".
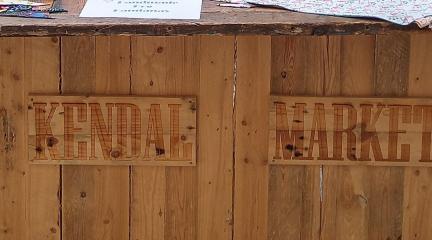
{"left": 215, "top": 0, "right": 432, "bottom": 27}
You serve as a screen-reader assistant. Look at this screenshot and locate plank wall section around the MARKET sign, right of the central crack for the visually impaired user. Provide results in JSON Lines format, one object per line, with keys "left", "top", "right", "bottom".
{"left": 234, "top": 33, "right": 432, "bottom": 240}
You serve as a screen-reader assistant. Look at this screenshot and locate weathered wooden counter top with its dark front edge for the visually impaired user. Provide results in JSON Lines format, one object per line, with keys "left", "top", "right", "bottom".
{"left": 0, "top": 0, "right": 426, "bottom": 36}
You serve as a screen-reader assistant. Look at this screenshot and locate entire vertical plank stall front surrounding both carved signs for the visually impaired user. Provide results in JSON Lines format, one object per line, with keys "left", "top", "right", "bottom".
{"left": 0, "top": 33, "right": 432, "bottom": 240}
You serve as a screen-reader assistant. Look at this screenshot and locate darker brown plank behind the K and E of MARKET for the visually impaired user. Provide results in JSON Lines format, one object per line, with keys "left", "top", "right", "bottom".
{"left": 368, "top": 33, "right": 409, "bottom": 239}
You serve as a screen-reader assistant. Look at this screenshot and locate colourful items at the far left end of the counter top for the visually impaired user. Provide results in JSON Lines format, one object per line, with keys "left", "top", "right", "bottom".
{"left": 0, "top": 0, "right": 67, "bottom": 19}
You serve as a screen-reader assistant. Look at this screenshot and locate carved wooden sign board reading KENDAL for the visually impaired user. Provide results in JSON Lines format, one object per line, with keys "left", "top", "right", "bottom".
{"left": 28, "top": 95, "right": 196, "bottom": 166}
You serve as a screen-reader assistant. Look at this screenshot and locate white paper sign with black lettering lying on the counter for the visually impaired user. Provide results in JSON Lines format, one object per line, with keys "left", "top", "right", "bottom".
{"left": 80, "top": 0, "right": 202, "bottom": 19}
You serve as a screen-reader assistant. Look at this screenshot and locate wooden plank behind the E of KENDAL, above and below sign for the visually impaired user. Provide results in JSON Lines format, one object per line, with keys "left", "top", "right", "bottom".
{"left": 61, "top": 37, "right": 96, "bottom": 240}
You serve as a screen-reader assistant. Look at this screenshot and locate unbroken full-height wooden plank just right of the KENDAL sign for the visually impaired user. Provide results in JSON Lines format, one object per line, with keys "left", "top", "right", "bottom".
{"left": 197, "top": 36, "right": 234, "bottom": 240}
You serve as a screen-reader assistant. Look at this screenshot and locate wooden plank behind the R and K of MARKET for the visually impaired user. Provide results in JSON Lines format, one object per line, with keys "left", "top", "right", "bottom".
{"left": 321, "top": 36, "right": 375, "bottom": 240}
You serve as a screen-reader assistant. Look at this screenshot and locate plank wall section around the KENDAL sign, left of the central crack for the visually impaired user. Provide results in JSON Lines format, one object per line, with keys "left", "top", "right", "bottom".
{"left": 0, "top": 36, "right": 234, "bottom": 240}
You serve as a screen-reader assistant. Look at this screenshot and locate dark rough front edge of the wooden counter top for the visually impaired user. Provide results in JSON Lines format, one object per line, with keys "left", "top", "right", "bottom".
{"left": 0, "top": 22, "right": 426, "bottom": 37}
